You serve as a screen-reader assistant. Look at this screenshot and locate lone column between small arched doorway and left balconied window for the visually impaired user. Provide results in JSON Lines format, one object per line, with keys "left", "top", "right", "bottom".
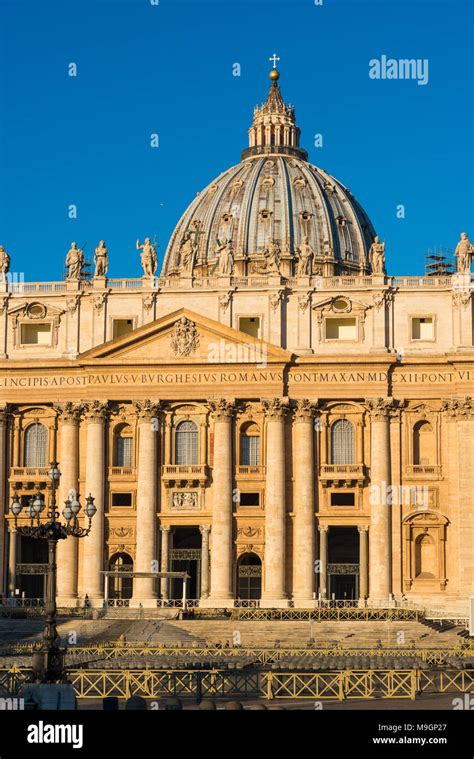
{"left": 130, "top": 400, "right": 159, "bottom": 608}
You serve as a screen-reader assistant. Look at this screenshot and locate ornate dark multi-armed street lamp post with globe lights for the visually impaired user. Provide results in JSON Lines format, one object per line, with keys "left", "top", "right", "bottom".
{"left": 10, "top": 460, "right": 97, "bottom": 683}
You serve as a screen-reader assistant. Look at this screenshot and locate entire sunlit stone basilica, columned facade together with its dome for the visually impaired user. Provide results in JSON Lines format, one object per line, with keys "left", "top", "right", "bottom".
{"left": 0, "top": 69, "right": 474, "bottom": 608}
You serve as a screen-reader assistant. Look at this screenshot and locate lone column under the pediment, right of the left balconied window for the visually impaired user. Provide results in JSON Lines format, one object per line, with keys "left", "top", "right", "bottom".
{"left": 203, "top": 398, "right": 234, "bottom": 607}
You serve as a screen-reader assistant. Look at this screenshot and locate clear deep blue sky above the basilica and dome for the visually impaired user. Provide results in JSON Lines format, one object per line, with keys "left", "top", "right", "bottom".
{"left": 0, "top": 0, "right": 474, "bottom": 281}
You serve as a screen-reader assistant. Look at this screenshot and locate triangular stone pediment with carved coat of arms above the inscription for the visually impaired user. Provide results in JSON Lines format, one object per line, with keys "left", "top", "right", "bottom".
{"left": 77, "top": 308, "right": 292, "bottom": 364}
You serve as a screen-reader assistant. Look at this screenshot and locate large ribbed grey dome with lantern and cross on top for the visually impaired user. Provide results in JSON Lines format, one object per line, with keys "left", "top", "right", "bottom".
{"left": 162, "top": 69, "right": 375, "bottom": 277}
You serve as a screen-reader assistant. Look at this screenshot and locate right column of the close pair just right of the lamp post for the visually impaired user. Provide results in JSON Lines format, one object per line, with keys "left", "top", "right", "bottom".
{"left": 83, "top": 401, "right": 107, "bottom": 606}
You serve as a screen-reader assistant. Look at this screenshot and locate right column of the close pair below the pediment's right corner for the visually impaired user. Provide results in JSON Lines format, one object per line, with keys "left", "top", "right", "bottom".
{"left": 293, "top": 400, "right": 315, "bottom": 608}
